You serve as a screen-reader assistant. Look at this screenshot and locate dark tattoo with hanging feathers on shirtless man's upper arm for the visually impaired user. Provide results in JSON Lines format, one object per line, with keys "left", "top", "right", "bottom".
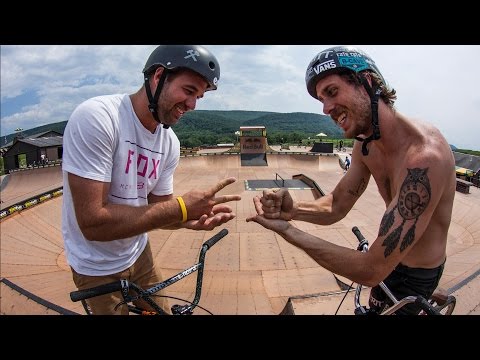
{"left": 378, "top": 168, "right": 431, "bottom": 257}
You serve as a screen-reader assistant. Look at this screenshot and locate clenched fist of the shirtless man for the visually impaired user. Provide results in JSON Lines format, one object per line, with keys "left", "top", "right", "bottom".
{"left": 260, "top": 188, "right": 294, "bottom": 221}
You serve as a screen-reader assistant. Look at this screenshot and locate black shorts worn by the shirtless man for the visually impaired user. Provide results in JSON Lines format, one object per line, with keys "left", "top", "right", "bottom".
{"left": 368, "top": 262, "right": 445, "bottom": 315}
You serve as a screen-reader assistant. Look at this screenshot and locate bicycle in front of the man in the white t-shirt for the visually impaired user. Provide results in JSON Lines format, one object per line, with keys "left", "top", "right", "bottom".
{"left": 70, "top": 229, "right": 228, "bottom": 315}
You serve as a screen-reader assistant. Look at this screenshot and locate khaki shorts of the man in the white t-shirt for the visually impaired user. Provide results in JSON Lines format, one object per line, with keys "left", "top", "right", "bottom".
{"left": 71, "top": 242, "right": 170, "bottom": 315}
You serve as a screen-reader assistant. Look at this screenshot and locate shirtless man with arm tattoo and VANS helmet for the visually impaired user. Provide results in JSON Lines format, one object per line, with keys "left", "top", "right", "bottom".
{"left": 247, "top": 47, "right": 455, "bottom": 314}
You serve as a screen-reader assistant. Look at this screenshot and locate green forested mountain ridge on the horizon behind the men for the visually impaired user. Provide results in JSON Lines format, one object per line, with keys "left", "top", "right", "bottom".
{"left": 1, "top": 110, "right": 343, "bottom": 147}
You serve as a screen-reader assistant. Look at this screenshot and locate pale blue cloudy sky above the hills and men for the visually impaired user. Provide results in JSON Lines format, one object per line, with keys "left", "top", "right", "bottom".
{"left": 0, "top": 44, "right": 480, "bottom": 150}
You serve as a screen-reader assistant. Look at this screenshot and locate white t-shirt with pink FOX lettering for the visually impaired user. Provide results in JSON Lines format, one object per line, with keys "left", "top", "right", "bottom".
{"left": 62, "top": 94, "right": 180, "bottom": 276}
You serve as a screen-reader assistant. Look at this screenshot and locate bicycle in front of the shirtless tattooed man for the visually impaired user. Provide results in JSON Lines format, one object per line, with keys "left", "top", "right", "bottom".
{"left": 335, "top": 226, "right": 457, "bottom": 315}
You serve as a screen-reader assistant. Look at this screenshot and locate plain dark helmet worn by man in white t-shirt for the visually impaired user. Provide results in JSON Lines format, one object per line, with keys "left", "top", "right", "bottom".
{"left": 143, "top": 45, "right": 220, "bottom": 91}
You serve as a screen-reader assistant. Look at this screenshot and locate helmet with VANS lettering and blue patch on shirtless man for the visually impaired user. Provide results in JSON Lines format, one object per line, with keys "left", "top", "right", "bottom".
{"left": 305, "top": 46, "right": 385, "bottom": 99}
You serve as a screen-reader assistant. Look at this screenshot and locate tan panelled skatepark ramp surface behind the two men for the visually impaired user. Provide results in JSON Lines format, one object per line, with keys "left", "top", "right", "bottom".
{"left": 0, "top": 154, "right": 480, "bottom": 315}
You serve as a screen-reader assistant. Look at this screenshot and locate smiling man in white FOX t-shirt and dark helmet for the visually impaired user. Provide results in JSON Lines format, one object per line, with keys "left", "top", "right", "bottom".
{"left": 62, "top": 45, "right": 240, "bottom": 314}
